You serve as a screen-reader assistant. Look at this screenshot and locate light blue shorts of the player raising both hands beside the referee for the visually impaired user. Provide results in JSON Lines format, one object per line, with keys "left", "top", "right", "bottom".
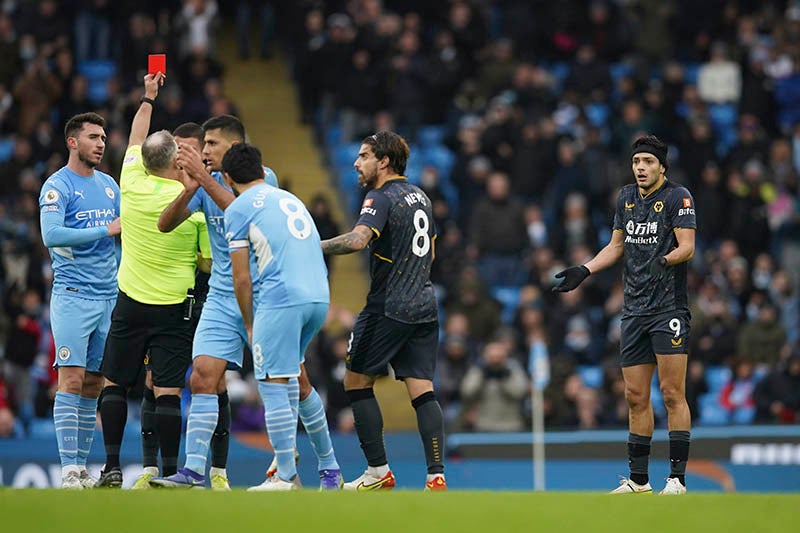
{"left": 192, "top": 289, "right": 247, "bottom": 367}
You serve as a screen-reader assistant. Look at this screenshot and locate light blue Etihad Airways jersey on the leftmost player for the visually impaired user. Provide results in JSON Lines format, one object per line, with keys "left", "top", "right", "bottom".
{"left": 39, "top": 167, "right": 120, "bottom": 299}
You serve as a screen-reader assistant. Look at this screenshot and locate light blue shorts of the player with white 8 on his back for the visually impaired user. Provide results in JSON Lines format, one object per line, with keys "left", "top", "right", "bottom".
{"left": 253, "top": 303, "right": 328, "bottom": 380}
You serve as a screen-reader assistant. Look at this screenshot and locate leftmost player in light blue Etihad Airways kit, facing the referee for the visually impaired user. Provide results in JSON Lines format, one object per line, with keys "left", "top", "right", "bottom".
{"left": 39, "top": 113, "right": 121, "bottom": 489}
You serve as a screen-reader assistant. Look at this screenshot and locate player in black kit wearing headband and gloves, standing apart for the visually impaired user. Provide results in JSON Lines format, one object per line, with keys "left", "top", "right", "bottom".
{"left": 554, "top": 135, "right": 696, "bottom": 494}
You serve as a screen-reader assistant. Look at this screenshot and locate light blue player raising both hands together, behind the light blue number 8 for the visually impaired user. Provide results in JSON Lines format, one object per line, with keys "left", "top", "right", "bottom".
{"left": 155, "top": 115, "right": 340, "bottom": 489}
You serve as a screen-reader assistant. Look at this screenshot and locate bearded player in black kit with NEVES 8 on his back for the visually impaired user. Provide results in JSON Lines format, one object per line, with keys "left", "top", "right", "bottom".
{"left": 322, "top": 131, "right": 447, "bottom": 491}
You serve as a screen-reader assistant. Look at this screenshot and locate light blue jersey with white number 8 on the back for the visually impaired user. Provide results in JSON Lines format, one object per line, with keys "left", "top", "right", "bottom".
{"left": 225, "top": 183, "right": 330, "bottom": 308}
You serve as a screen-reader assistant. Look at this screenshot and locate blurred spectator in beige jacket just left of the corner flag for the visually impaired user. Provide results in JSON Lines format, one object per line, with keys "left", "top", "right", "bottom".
{"left": 461, "top": 341, "right": 528, "bottom": 431}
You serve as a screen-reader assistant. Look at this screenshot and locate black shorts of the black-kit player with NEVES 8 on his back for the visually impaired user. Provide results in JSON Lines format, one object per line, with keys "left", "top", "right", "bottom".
{"left": 347, "top": 312, "right": 439, "bottom": 381}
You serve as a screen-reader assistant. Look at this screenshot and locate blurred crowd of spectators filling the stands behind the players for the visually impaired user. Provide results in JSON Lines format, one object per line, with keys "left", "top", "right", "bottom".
{"left": 0, "top": 0, "right": 800, "bottom": 436}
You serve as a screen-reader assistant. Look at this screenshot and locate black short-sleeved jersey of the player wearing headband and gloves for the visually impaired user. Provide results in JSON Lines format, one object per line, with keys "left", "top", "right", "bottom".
{"left": 614, "top": 180, "right": 697, "bottom": 316}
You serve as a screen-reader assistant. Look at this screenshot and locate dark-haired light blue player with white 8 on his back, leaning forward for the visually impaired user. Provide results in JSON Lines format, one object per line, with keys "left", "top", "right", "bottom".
{"left": 222, "top": 144, "right": 334, "bottom": 491}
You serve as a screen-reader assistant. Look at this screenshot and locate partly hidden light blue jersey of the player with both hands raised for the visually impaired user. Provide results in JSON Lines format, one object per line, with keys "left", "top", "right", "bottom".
{"left": 189, "top": 167, "right": 278, "bottom": 294}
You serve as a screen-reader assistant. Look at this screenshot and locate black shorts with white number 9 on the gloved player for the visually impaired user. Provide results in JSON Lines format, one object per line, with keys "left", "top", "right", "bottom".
{"left": 620, "top": 309, "right": 692, "bottom": 366}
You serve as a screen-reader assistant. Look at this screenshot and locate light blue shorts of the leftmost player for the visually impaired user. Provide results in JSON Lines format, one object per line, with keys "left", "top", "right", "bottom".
{"left": 50, "top": 293, "right": 117, "bottom": 372}
